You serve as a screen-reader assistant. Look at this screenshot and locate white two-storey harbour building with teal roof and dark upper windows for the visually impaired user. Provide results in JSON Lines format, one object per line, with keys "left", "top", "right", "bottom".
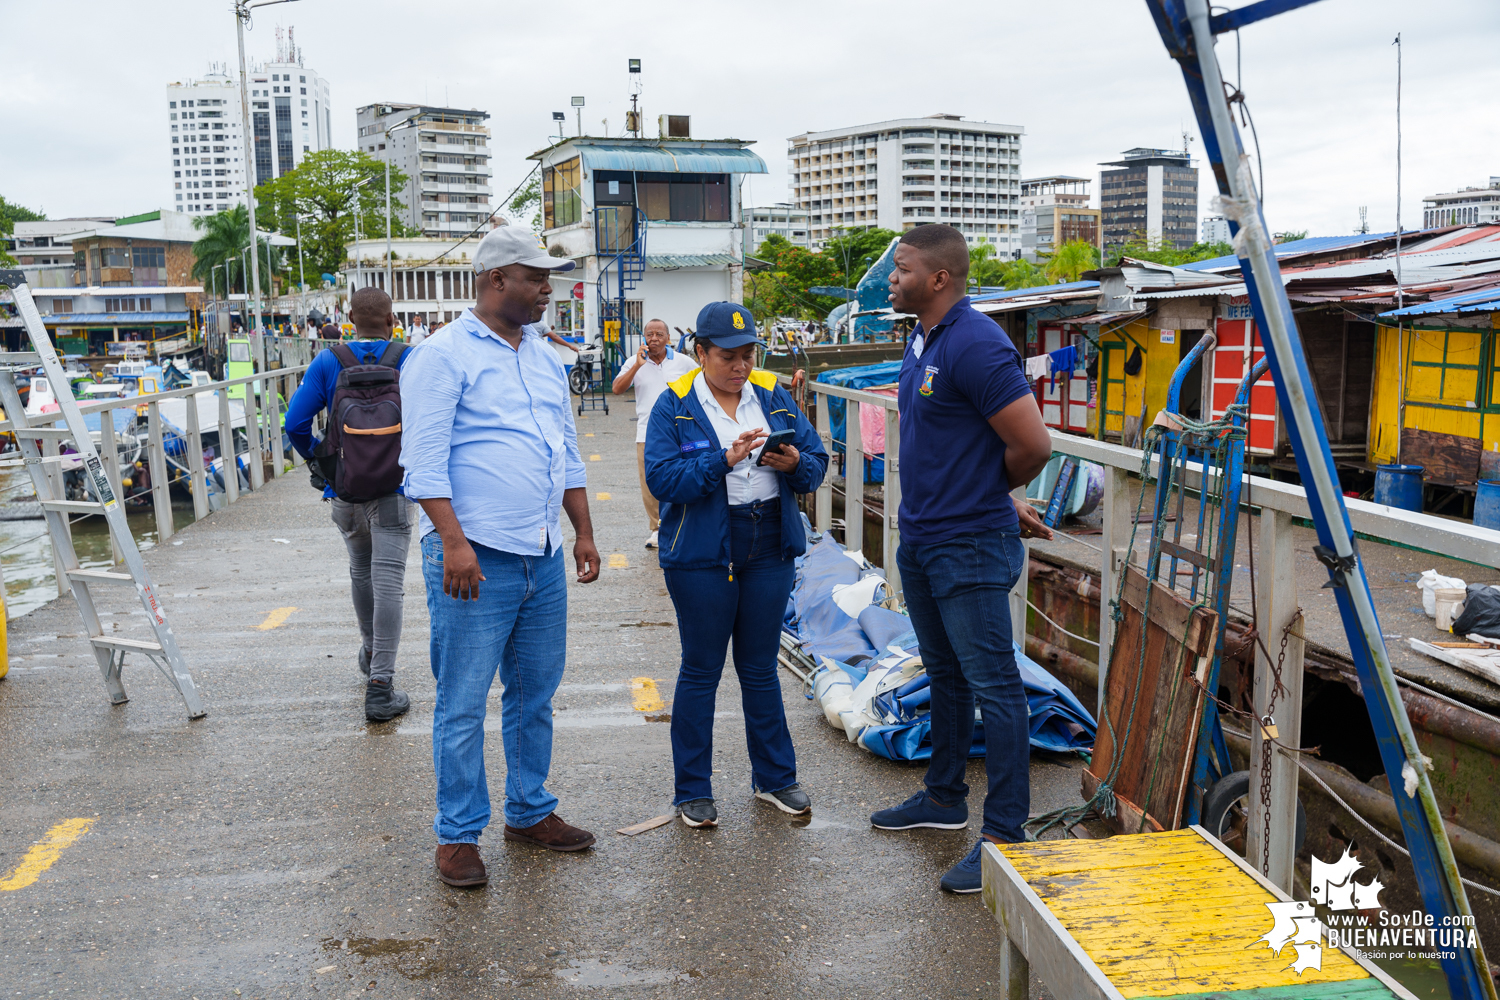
{"left": 531, "top": 125, "right": 767, "bottom": 347}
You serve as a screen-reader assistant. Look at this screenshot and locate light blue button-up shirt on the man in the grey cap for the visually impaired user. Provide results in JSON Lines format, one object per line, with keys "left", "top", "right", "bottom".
{"left": 401, "top": 309, "right": 587, "bottom": 556}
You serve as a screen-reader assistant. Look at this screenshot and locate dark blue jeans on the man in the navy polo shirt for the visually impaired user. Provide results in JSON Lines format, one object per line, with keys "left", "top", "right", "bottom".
{"left": 896, "top": 531, "right": 1031, "bottom": 843}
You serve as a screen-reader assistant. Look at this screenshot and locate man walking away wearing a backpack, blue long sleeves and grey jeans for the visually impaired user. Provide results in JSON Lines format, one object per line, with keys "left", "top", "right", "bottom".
{"left": 287, "top": 288, "right": 416, "bottom": 723}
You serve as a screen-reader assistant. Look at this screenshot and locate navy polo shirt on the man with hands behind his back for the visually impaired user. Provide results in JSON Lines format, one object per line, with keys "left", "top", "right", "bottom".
{"left": 897, "top": 297, "right": 1032, "bottom": 546}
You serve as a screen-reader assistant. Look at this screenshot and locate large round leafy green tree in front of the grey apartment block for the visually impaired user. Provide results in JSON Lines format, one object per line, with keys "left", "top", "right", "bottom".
{"left": 255, "top": 150, "right": 419, "bottom": 285}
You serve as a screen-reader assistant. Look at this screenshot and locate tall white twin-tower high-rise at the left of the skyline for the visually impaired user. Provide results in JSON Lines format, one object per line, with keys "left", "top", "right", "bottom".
{"left": 167, "top": 28, "right": 333, "bottom": 213}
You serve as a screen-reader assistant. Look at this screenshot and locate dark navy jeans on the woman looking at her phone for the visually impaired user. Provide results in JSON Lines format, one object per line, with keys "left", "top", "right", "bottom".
{"left": 663, "top": 499, "right": 797, "bottom": 805}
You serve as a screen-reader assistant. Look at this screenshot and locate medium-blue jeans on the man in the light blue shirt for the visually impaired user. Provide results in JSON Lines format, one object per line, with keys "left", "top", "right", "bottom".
{"left": 422, "top": 531, "right": 567, "bottom": 844}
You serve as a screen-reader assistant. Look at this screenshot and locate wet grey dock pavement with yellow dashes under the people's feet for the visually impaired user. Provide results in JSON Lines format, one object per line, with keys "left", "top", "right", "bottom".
{"left": 0, "top": 405, "right": 1082, "bottom": 1000}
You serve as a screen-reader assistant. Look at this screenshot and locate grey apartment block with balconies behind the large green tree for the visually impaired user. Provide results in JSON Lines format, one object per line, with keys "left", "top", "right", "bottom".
{"left": 356, "top": 102, "right": 495, "bottom": 237}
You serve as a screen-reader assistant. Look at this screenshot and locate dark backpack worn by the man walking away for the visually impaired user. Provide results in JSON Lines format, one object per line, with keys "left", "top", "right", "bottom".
{"left": 314, "top": 342, "right": 407, "bottom": 504}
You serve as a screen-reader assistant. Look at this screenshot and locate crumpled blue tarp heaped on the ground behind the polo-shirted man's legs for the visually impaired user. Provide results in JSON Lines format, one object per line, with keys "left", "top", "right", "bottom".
{"left": 786, "top": 537, "right": 1097, "bottom": 760}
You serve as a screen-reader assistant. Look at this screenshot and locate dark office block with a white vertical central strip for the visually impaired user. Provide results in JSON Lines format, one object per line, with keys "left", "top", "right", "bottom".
{"left": 1100, "top": 147, "right": 1199, "bottom": 250}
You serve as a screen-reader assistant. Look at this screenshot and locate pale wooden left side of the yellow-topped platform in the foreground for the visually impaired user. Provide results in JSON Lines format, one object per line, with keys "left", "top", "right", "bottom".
{"left": 980, "top": 844, "right": 1125, "bottom": 1000}
